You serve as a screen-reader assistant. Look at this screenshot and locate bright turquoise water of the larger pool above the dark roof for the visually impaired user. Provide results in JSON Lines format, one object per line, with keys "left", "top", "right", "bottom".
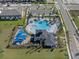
{"left": 31, "top": 20, "right": 50, "bottom": 33}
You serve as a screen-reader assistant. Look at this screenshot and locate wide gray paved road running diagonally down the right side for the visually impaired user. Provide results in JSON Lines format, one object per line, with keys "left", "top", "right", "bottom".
{"left": 56, "top": 0, "right": 79, "bottom": 59}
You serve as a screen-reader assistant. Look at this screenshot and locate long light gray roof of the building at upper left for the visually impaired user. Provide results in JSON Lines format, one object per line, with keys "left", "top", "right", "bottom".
{"left": 0, "top": 9, "right": 21, "bottom": 16}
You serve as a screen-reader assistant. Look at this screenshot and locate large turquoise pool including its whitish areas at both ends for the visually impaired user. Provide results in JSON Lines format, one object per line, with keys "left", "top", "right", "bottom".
{"left": 26, "top": 20, "right": 58, "bottom": 34}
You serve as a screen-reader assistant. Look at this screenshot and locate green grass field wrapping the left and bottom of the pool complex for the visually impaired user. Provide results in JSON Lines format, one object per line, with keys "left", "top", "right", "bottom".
{"left": 0, "top": 21, "right": 68, "bottom": 59}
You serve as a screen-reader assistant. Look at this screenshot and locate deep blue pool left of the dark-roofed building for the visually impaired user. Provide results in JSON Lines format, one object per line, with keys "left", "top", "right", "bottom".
{"left": 14, "top": 27, "right": 28, "bottom": 44}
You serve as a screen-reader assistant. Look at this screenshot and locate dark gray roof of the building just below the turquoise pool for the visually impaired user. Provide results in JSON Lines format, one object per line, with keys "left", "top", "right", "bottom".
{"left": 35, "top": 30, "right": 57, "bottom": 47}
